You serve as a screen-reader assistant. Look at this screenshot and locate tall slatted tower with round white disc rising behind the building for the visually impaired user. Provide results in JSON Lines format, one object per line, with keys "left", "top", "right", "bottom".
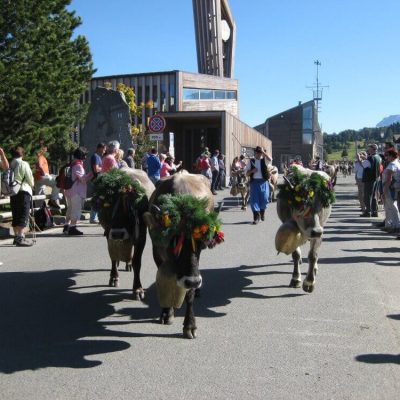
{"left": 193, "top": 0, "right": 236, "bottom": 78}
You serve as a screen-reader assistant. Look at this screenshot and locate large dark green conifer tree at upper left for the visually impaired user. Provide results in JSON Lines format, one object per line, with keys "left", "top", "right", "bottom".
{"left": 0, "top": 0, "right": 94, "bottom": 160}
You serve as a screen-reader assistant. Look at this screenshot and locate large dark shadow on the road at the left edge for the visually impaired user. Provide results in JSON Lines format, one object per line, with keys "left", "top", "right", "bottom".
{"left": 0, "top": 267, "right": 130, "bottom": 373}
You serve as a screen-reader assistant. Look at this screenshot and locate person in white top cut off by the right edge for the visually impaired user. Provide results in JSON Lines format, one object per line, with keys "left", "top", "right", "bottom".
{"left": 382, "top": 150, "right": 400, "bottom": 233}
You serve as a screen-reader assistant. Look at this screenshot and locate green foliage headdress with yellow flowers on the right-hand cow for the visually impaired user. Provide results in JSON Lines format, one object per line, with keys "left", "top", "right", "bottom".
{"left": 278, "top": 168, "right": 335, "bottom": 210}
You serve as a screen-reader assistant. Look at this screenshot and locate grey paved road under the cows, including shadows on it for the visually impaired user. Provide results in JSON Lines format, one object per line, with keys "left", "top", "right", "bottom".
{"left": 0, "top": 178, "right": 400, "bottom": 400}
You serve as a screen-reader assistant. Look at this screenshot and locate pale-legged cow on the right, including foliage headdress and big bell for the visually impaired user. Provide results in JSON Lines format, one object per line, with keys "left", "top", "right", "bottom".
{"left": 275, "top": 167, "right": 334, "bottom": 293}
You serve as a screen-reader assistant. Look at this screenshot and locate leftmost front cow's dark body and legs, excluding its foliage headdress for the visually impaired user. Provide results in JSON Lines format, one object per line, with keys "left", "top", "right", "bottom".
{"left": 95, "top": 167, "right": 155, "bottom": 300}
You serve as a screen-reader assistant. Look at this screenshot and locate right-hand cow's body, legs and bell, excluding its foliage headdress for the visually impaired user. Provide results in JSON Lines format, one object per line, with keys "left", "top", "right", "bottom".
{"left": 275, "top": 167, "right": 334, "bottom": 293}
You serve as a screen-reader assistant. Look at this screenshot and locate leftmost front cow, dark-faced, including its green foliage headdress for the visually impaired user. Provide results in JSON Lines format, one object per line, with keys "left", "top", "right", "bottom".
{"left": 92, "top": 168, "right": 154, "bottom": 300}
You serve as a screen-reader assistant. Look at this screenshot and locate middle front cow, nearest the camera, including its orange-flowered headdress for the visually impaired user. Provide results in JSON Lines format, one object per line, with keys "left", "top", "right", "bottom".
{"left": 144, "top": 173, "right": 224, "bottom": 339}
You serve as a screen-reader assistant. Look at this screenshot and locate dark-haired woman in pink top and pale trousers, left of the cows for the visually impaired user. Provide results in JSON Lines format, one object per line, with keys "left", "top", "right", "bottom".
{"left": 63, "top": 147, "right": 93, "bottom": 236}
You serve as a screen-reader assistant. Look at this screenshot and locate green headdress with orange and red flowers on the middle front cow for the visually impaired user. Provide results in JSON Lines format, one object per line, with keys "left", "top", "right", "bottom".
{"left": 154, "top": 194, "right": 224, "bottom": 256}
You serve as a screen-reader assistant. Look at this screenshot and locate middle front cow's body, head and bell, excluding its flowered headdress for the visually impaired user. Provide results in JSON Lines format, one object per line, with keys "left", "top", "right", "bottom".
{"left": 144, "top": 173, "right": 222, "bottom": 339}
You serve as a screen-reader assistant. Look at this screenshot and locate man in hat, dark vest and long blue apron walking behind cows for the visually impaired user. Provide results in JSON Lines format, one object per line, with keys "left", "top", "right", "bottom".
{"left": 245, "top": 146, "right": 272, "bottom": 225}
